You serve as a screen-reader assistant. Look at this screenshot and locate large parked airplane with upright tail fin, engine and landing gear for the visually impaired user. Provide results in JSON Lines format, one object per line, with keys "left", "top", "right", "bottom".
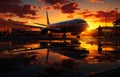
{"left": 35, "top": 11, "right": 89, "bottom": 38}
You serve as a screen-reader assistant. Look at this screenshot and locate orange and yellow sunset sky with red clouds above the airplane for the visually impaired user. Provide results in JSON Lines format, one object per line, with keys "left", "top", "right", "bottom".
{"left": 0, "top": 0, "right": 120, "bottom": 28}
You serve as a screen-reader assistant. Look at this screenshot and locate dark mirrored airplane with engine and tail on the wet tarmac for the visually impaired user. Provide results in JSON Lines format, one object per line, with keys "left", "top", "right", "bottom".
{"left": 20, "top": 40, "right": 89, "bottom": 59}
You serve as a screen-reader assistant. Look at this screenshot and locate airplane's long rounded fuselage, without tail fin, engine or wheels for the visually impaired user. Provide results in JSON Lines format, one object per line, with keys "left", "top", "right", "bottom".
{"left": 47, "top": 19, "right": 88, "bottom": 33}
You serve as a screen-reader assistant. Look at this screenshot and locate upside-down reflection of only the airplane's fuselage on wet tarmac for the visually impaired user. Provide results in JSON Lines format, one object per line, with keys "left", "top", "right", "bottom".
{"left": 45, "top": 41, "right": 89, "bottom": 59}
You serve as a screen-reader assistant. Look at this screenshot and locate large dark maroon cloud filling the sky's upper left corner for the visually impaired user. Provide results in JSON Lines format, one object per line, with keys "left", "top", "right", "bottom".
{"left": 0, "top": 0, "right": 38, "bottom": 17}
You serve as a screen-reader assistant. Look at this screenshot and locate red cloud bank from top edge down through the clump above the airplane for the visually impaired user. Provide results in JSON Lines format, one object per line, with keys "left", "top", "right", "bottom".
{"left": 38, "top": 0, "right": 80, "bottom": 14}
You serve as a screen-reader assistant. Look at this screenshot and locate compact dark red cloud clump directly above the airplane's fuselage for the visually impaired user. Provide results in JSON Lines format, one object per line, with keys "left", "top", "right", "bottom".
{"left": 61, "top": 2, "right": 80, "bottom": 14}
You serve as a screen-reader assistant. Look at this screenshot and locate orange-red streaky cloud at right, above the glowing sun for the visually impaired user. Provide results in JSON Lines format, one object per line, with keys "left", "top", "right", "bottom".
{"left": 80, "top": 10, "right": 120, "bottom": 22}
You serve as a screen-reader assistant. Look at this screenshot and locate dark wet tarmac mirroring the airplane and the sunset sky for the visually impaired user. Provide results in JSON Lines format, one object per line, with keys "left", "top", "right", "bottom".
{"left": 0, "top": 36, "right": 120, "bottom": 77}
